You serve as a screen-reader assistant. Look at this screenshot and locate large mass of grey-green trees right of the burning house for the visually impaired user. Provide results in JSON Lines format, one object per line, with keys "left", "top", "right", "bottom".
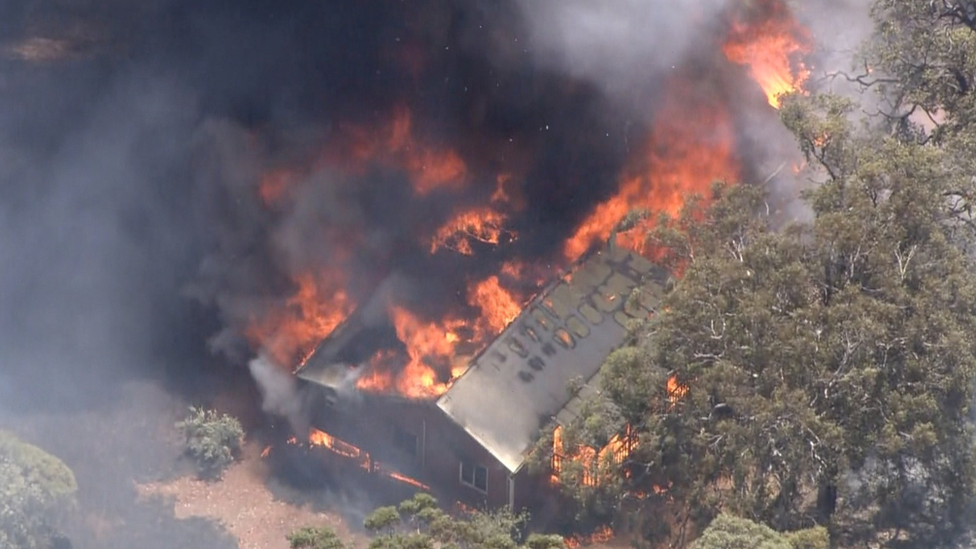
{"left": 548, "top": 0, "right": 976, "bottom": 547}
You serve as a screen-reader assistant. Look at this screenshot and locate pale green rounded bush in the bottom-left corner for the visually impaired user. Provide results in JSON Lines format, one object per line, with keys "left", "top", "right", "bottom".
{"left": 0, "top": 431, "right": 78, "bottom": 549}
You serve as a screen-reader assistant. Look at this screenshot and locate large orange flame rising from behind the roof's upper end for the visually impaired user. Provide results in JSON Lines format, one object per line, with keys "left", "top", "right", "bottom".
{"left": 563, "top": 79, "right": 739, "bottom": 261}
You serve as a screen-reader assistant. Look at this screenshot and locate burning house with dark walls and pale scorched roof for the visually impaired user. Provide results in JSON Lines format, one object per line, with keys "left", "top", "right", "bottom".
{"left": 298, "top": 248, "right": 667, "bottom": 507}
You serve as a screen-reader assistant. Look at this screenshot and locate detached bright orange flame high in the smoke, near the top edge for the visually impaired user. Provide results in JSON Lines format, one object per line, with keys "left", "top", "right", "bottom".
{"left": 722, "top": 0, "right": 812, "bottom": 108}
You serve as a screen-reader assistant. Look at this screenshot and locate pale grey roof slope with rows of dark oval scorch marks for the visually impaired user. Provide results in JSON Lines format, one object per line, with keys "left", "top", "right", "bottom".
{"left": 437, "top": 248, "right": 667, "bottom": 473}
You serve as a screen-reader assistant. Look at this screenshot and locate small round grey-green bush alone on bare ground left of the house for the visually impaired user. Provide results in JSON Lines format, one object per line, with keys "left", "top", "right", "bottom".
{"left": 176, "top": 406, "right": 244, "bottom": 477}
